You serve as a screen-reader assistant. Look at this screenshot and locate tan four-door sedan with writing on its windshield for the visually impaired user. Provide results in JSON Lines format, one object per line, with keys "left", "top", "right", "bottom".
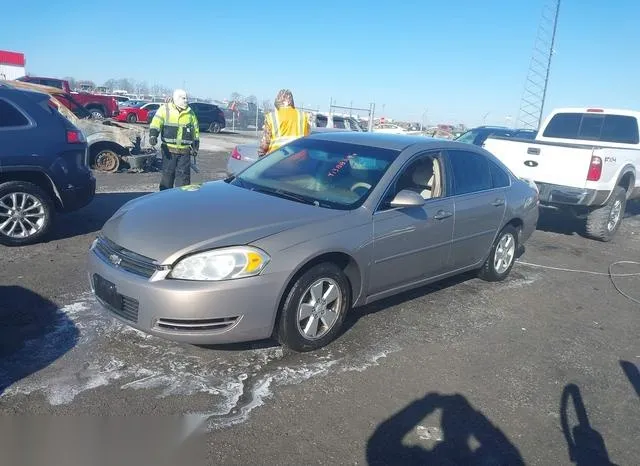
{"left": 88, "top": 131, "right": 538, "bottom": 351}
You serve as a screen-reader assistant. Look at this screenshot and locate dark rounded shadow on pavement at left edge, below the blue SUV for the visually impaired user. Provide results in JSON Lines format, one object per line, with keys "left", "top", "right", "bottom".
{"left": 0, "top": 286, "right": 80, "bottom": 395}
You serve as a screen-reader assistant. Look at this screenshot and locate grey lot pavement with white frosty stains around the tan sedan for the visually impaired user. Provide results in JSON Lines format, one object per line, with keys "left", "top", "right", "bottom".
{"left": 0, "top": 132, "right": 640, "bottom": 465}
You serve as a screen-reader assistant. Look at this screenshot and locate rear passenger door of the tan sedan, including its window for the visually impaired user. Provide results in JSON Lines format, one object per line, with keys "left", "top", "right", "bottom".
{"left": 447, "top": 150, "right": 509, "bottom": 269}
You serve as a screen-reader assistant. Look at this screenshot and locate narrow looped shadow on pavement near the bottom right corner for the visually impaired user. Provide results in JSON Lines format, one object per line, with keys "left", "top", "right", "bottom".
{"left": 560, "top": 384, "right": 614, "bottom": 466}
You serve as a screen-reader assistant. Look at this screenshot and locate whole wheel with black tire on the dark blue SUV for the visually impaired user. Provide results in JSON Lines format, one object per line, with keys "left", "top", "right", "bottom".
{"left": 0, "top": 181, "right": 55, "bottom": 246}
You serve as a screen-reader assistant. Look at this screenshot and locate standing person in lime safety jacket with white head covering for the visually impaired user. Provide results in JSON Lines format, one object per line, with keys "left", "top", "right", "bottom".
{"left": 149, "top": 89, "right": 200, "bottom": 191}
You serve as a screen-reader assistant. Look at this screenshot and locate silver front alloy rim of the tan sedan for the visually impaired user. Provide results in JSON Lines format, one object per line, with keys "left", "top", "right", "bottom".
{"left": 296, "top": 278, "right": 343, "bottom": 340}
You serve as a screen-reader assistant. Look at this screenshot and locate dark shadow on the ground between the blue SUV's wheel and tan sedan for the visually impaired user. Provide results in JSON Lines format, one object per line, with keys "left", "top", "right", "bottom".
{"left": 49, "top": 192, "right": 151, "bottom": 241}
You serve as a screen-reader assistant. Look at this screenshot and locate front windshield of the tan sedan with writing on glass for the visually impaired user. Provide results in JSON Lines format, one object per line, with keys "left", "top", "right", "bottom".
{"left": 229, "top": 138, "right": 400, "bottom": 210}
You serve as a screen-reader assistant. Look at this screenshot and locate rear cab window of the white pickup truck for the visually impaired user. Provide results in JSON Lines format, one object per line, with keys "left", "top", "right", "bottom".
{"left": 543, "top": 113, "right": 640, "bottom": 144}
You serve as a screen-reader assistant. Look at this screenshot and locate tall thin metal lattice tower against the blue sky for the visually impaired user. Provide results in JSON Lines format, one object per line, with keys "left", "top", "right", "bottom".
{"left": 518, "top": 0, "right": 561, "bottom": 130}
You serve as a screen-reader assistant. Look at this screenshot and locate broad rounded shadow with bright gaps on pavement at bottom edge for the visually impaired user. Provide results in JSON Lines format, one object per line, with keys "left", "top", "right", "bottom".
{"left": 366, "top": 392, "right": 524, "bottom": 465}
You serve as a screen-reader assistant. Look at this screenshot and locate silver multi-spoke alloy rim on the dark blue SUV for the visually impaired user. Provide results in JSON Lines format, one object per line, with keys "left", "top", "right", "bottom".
{"left": 0, "top": 192, "right": 46, "bottom": 239}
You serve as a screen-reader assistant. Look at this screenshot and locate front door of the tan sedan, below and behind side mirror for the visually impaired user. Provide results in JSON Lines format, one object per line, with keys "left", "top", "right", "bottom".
{"left": 368, "top": 151, "right": 454, "bottom": 296}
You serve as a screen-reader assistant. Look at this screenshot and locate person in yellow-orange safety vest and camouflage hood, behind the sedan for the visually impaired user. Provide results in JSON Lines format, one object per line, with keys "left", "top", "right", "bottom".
{"left": 258, "top": 89, "right": 311, "bottom": 157}
